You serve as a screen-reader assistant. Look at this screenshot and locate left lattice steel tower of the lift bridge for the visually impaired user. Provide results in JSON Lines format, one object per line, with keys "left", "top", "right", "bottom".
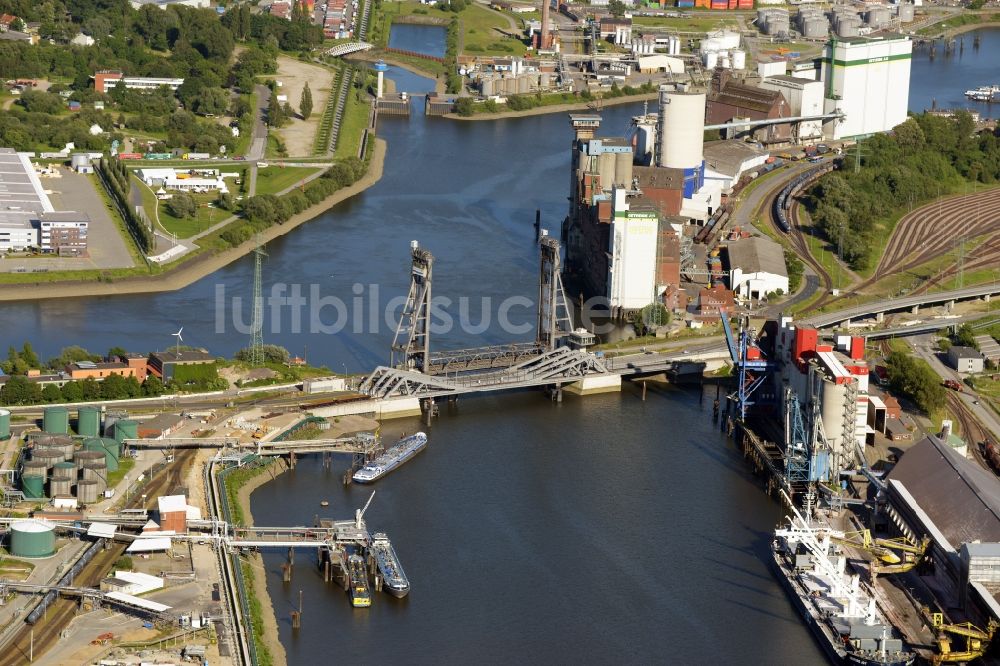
{"left": 389, "top": 241, "right": 434, "bottom": 372}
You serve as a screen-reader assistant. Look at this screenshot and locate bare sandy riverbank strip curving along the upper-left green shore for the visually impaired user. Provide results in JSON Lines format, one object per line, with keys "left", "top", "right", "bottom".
{"left": 0, "top": 138, "right": 388, "bottom": 302}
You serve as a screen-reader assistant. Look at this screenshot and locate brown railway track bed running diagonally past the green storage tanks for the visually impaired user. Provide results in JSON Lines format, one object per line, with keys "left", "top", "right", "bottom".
{"left": 0, "top": 449, "right": 195, "bottom": 666}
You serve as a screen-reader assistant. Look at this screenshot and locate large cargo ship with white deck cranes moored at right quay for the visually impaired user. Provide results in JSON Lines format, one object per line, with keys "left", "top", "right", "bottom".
{"left": 772, "top": 500, "right": 916, "bottom": 666}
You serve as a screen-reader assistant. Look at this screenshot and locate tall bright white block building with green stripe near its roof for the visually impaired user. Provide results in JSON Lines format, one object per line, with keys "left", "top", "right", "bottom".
{"left": 821, "top": 36, "right": 913, "bottom": 140}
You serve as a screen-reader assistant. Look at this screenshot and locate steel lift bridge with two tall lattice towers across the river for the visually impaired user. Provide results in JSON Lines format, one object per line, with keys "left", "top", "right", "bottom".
{"left": 360, "top": 236, "right": 608, "bottom": 398}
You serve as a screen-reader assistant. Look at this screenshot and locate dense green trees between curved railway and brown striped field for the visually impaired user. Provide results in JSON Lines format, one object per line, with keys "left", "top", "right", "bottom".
{"left": 806, "top": 111, "right": 1000, "bottom": 270}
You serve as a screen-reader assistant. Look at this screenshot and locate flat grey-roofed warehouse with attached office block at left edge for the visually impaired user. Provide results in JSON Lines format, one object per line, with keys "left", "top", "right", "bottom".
{"left": 0, "top": 148, "right": 90, "bottom": 256}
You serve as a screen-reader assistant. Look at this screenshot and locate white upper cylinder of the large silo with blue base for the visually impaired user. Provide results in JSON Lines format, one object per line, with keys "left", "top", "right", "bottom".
{"left": 657, "top": 89, "right": 705, "bottom": 169}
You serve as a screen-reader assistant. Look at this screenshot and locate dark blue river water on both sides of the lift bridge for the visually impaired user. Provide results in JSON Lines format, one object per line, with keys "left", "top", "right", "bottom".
{"left": 0, "top": 31, "right": 1000, "bottom": 664}
